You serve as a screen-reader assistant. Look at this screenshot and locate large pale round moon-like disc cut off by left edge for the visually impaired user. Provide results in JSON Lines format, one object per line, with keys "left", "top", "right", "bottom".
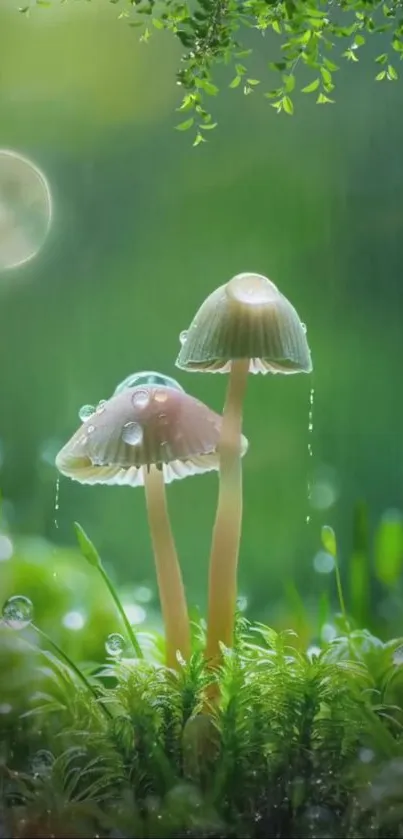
{"left": 0, "top": 149, "right": 52, "bottom": 271}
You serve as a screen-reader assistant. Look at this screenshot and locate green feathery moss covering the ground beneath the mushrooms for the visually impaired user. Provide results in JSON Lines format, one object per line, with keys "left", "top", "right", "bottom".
{"left": 0, "top": 620, "right": 403, "bottom": 839}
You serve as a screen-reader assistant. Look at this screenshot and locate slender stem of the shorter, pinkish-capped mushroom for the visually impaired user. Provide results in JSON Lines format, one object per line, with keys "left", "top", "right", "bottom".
{"left": 143, "top": 466, "right": 190, "bottom": 669}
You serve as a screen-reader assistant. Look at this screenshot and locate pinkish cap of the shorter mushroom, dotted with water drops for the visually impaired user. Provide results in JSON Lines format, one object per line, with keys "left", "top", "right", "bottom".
{"left": 56, "top": 385, "right": 248, "bottom": 486}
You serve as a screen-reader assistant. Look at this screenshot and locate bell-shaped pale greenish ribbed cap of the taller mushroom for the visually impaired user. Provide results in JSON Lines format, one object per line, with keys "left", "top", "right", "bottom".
{"left": 176, "top": 273, "right": 312, "bottom": 373}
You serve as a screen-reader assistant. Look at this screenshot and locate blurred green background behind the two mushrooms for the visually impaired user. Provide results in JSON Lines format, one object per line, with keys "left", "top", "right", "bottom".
{"left": 0, "top": 0, "right": 403, "bottom": 656}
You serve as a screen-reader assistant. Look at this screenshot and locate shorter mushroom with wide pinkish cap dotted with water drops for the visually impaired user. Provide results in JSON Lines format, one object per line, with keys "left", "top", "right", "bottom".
{"left": 56, "top": 385, "right": 247, "bottom": 668}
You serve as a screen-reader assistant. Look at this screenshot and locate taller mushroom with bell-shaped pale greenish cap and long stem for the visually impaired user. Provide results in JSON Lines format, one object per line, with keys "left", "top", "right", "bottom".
{"left": 176, "top": 273, "right": 312, "bottom": 664}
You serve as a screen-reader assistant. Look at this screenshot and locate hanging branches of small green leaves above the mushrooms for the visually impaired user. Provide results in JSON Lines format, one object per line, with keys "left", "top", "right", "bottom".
{"left": 21, "top": 0, "right": 403, "bottom": 145}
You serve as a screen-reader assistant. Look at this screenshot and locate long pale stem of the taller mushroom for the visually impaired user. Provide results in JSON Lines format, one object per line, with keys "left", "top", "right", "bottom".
{"left": 206, "top": 359, "right": 249, "bottom": 666}
